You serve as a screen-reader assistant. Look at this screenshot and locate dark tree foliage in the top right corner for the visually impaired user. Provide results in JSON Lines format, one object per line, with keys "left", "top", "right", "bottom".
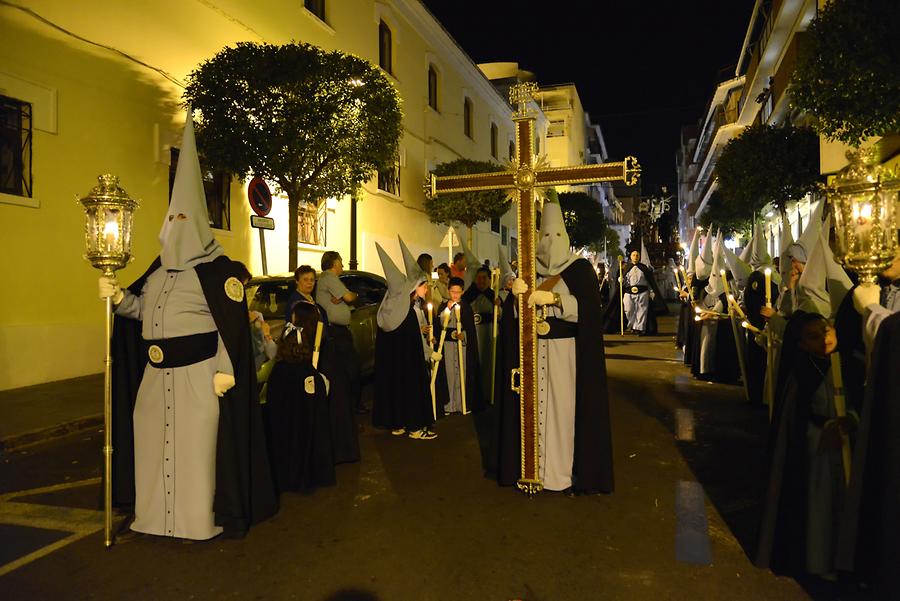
{"left": 791, "top": 0, "right": 900, "bottom": 146}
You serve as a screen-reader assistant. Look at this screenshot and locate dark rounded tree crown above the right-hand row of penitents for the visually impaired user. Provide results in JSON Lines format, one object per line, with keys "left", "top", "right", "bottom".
{"left": 716, "top": 124, "right": 820, "bottom": 216}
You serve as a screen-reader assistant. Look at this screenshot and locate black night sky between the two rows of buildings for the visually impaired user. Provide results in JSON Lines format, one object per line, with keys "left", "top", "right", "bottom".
{"left": 423, "top": 0, "right": 754, "bottom": 194}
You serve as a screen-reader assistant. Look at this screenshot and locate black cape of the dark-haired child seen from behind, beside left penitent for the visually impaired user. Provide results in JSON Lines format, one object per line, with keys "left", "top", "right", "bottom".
{"left": 265, "top": 361, "right": 335, "bottom": 492}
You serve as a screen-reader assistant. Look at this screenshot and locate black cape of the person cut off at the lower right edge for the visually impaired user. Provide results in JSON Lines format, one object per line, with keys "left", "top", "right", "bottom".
{"left": 838, "top": 313, "right": 900, "bottom": 599}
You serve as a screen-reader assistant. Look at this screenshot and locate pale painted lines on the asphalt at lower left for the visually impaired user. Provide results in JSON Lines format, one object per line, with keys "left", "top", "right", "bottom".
{"left": 0, "top": 478, "right": 103, "bottom": 576}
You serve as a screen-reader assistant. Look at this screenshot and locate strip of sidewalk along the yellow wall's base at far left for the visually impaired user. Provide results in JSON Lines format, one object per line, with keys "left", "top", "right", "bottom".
{"left": 0, "top": 373, "right": 103, "bottom": 451}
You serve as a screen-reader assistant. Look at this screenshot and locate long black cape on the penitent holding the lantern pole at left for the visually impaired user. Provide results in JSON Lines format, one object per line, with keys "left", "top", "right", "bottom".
{"left": 112, "top": 256, "right": 278, "bottom": 537}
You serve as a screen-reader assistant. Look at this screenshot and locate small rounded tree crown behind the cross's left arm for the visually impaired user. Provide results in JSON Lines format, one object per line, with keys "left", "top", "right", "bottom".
{"left": 425, "top": 159, "right": 509, "bottom": 228}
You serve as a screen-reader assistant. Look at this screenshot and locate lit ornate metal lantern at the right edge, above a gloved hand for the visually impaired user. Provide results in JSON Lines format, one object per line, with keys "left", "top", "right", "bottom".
{"left": 827, "top": 148, "right": 900, "bottom": 284}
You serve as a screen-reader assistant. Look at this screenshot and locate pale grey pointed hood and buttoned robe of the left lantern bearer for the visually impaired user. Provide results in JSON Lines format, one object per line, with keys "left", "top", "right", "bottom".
{"left": 116, "top": 113, "right": 227, "bottom": 540}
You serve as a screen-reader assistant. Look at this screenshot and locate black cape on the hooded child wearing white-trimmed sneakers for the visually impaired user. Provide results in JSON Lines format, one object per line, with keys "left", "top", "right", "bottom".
{"left": 372, "top": 305, "right": 434, "bottom": 431}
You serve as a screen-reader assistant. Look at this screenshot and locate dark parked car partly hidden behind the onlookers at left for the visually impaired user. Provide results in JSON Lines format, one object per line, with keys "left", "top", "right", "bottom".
{"left": 246, "top": 271, "right": 387, "bottom": 376}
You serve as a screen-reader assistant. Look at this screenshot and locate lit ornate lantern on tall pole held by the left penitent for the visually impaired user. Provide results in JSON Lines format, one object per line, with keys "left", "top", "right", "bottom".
{"left": 78, "top": 174, "right": 138, "bottom": 548}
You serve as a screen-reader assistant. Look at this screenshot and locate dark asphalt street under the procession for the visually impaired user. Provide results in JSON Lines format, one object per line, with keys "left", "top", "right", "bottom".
{"left": 0, "top": 318, "right": 856, "bottom": 601}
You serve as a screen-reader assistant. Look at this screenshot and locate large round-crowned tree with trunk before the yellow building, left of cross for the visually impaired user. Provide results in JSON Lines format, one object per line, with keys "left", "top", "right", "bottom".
{"left": 184, "top": 42, "right": 402, "bottom": 270}
